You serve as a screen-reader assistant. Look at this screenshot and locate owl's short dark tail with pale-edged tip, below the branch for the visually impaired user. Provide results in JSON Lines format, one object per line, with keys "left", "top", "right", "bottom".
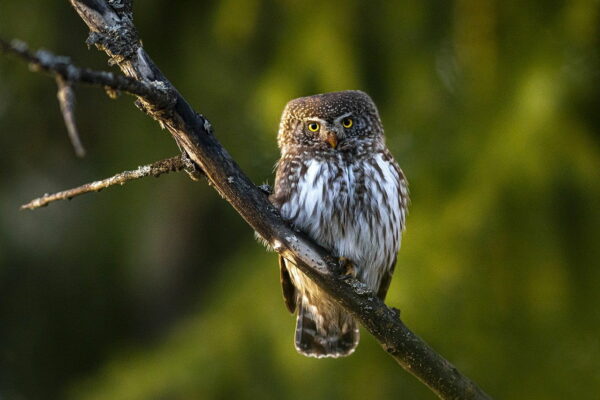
{"left": 296, "top": 299, "right": 360, "bottom": 358}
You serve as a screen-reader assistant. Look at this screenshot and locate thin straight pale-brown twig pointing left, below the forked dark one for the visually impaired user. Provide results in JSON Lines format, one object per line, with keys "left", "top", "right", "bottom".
{"left": 21, "top": 156, "right": 186, "bottom": 210}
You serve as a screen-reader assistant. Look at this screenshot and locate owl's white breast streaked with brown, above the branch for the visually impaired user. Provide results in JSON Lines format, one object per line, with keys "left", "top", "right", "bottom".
{"left": 280, "top": 155, "right": 404, "bottom": 287}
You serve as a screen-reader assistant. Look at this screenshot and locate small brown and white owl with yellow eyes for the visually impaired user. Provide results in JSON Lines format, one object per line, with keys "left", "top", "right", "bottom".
{"left": 270, "top": 90, "right": 408, "bottom": 358}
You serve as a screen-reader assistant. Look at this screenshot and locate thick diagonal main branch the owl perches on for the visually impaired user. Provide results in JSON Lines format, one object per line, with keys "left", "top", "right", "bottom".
{"left": 2, "top": 0, "right": 489, "bottom": 399}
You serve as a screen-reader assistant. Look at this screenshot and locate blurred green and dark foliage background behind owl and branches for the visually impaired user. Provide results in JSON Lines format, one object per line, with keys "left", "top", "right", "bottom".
{"left": 0, "top": 0, "right": 600, "bottom": 400}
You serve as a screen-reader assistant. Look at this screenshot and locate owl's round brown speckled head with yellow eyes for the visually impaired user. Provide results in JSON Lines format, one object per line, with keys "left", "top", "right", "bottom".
{"left": 278, "top": 90, "right": 383, "bottom": 154}
